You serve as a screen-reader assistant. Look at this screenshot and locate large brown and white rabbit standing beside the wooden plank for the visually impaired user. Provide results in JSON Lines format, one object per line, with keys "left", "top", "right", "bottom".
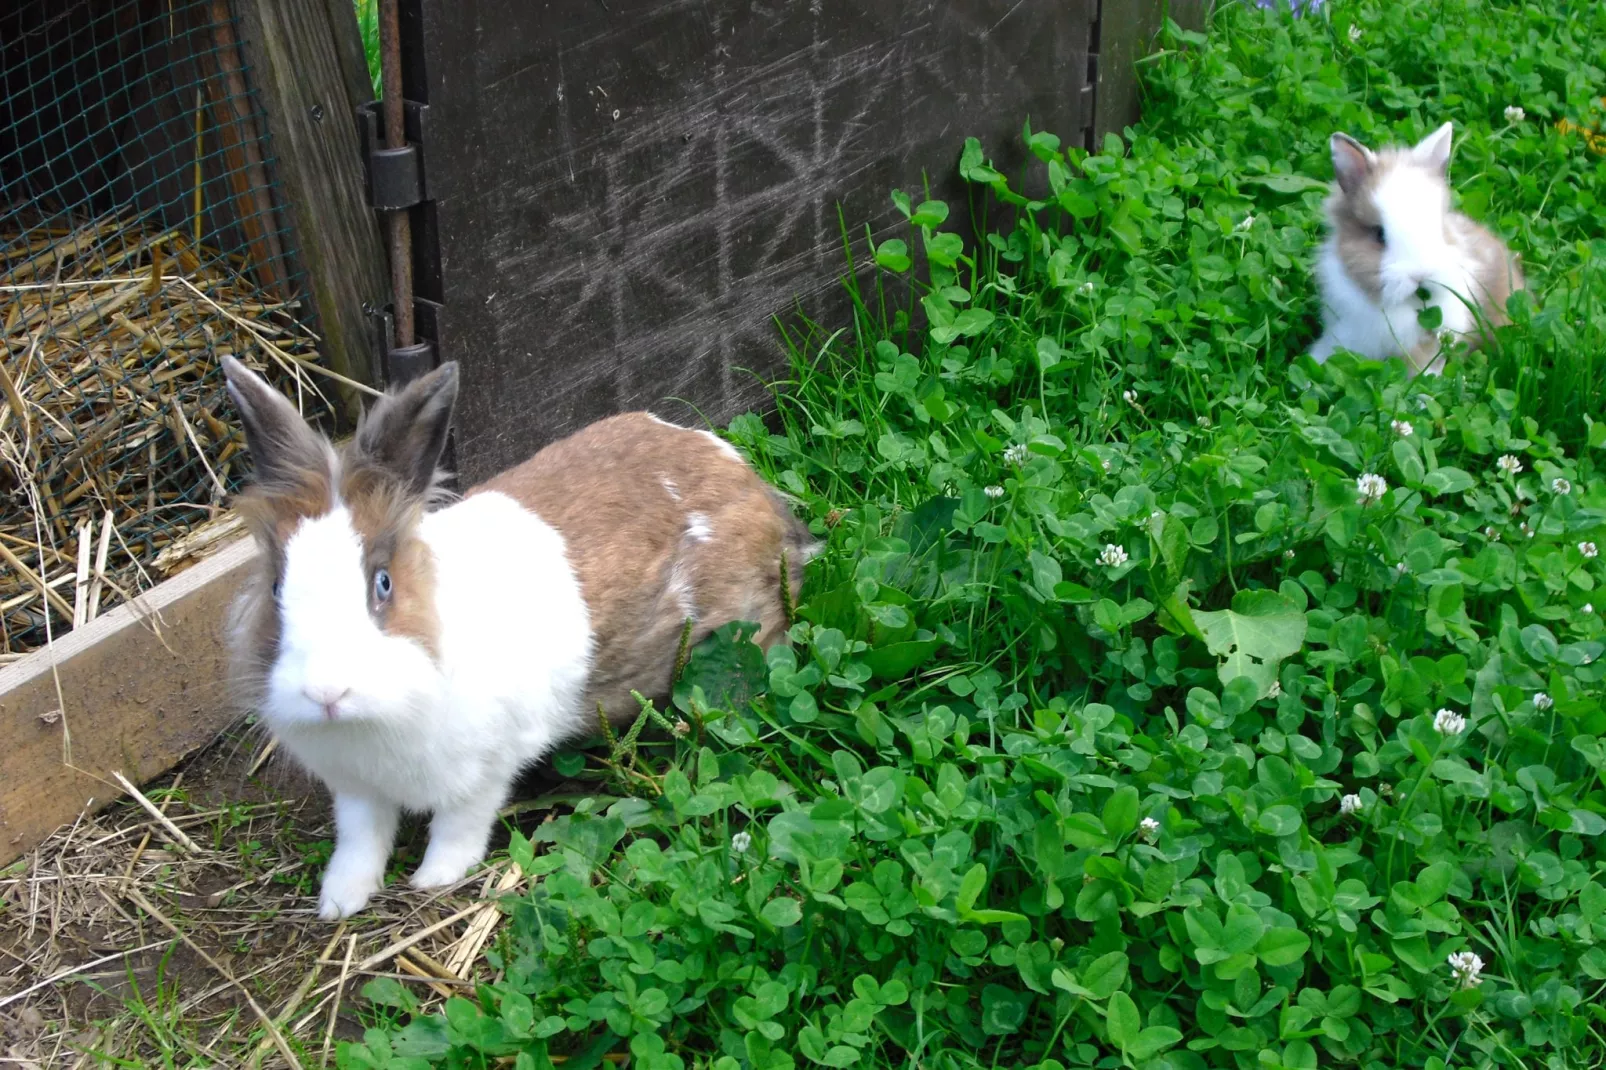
{"left": 223, "top": 357, "right": 813, "bottom": 921}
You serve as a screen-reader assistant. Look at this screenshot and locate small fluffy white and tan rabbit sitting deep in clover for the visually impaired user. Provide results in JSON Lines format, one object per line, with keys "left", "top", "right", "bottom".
{"left": 1310, "top": 122, "right": 1524, "bottom": 374}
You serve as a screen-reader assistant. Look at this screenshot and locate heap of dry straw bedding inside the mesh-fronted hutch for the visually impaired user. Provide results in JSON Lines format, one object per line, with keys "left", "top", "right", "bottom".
{"left": 0, "top": 215, "right": 331, "bottom": 665}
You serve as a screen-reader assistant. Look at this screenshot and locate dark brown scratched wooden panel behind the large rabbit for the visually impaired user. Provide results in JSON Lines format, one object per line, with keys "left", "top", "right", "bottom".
{"left": 419, "top": 0, "right": 1092, "bottom": 480}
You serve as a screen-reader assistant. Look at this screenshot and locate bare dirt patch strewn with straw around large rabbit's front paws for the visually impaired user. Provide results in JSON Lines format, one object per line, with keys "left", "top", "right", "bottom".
{"left": 0, "top": 719, "right": 552, "bottom": 1070}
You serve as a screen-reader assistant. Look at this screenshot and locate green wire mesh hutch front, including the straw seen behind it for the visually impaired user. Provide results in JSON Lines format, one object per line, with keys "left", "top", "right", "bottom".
{"left": 0, "top": 0, "right": 342, "bottom": 664}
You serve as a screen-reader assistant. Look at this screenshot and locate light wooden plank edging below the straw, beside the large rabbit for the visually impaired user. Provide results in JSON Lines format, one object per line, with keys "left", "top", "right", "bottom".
{"left": 0, "top": 538, "right": 257, "bottom": 866}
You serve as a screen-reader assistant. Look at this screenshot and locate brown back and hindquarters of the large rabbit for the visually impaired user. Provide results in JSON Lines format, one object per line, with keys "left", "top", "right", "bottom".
{"left": 469, "top": 413, "right": 809, "bottom": 720}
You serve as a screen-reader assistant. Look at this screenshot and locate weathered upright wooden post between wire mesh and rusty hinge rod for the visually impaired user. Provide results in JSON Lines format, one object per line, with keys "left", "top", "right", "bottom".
{"left": 234, "top": 0, "right": 389, "bottom": 415}
